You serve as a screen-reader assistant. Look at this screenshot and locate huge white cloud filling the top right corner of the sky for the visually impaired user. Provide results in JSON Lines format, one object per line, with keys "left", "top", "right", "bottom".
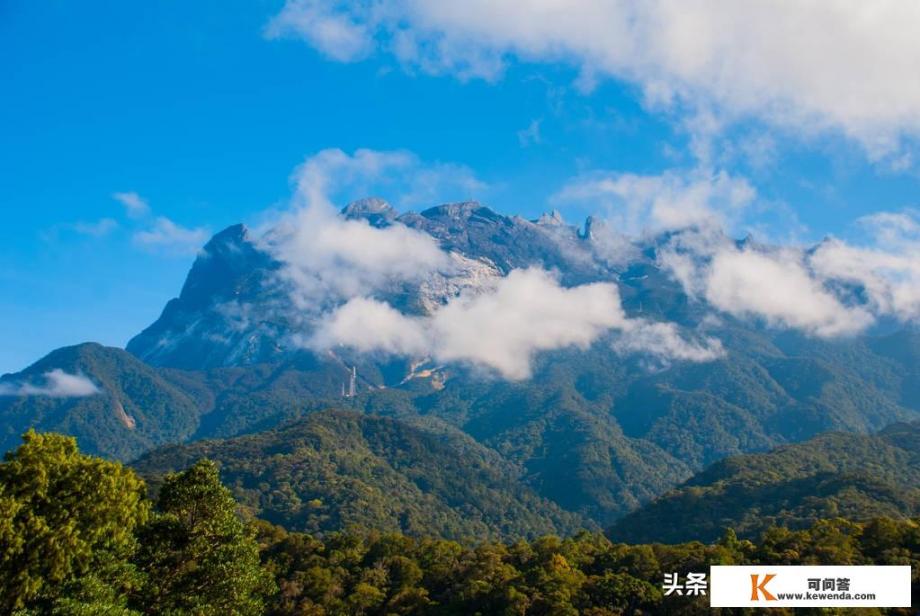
{"left": 268, "top": 0, "right": 920, "bottom": 156}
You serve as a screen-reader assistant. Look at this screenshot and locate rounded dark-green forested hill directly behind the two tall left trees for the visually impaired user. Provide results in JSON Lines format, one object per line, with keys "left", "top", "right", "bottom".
{"left": 134, "top": 411, "right": 590, "bottom": 540}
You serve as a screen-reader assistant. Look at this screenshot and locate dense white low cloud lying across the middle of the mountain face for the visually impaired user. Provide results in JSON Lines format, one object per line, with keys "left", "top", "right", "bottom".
{"left": 310, "top": 269, "right": 722, "bottom": 380}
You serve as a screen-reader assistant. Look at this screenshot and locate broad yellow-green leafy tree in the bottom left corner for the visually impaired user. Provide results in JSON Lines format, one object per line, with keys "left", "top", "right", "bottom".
{"left": 0, "top": 430, "right": 150, "bottom": 614}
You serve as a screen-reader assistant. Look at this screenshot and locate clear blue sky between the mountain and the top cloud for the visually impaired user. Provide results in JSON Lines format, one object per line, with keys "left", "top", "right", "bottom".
{"left": 0, "top": 0, "right": 920, "bottom": 372}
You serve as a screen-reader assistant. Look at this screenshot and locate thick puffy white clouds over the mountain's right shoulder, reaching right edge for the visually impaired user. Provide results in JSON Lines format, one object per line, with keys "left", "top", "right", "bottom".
{"left": 659, "top": 212, "right": 920, "bottom": 338}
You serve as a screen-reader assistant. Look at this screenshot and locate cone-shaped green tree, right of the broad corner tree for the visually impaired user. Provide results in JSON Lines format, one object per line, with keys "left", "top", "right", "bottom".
{"left": 137, "top": 460, "right": 274, "bottom": 616}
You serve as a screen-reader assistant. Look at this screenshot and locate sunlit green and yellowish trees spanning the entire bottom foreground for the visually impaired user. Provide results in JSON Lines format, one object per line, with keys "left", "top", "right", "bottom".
{"left": 0, "top": 433, "right": 920, "bottom": 616}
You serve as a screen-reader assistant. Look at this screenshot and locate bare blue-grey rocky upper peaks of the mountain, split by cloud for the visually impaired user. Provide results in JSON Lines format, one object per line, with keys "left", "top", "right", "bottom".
{"left": 127, "top": 200, "right": 610, "bottom": 370}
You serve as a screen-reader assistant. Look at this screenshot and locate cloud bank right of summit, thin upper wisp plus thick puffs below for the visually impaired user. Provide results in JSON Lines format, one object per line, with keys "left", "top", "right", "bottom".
{"left": 551, "top": 161, "right": 920, "bottom": 338}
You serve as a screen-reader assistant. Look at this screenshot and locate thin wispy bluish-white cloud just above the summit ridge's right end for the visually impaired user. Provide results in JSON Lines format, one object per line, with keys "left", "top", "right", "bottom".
{"left": 551, "top": 170, "right": 757, "bottom": 236}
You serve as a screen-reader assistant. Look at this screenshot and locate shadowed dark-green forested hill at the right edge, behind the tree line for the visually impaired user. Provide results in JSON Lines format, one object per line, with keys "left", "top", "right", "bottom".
{"left": 610, "top": 423, "right": 920, "bottom": 543}
